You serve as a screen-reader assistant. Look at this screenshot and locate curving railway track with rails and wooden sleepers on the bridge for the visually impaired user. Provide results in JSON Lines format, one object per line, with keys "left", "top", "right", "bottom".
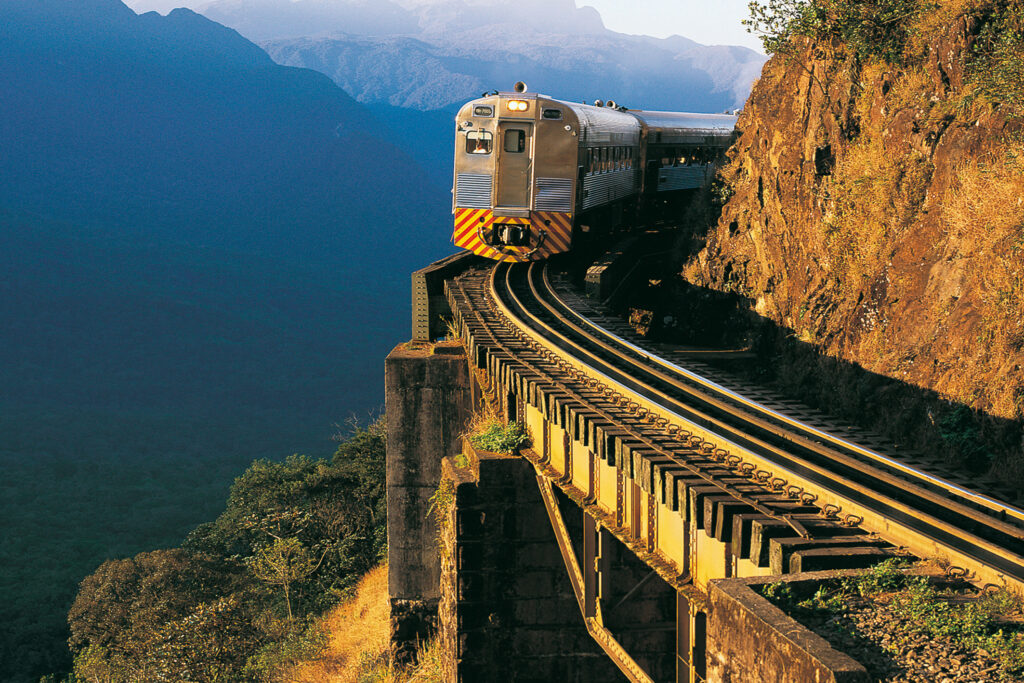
{"left": 449, "top": 262, "right": 1024, "bottom": 590}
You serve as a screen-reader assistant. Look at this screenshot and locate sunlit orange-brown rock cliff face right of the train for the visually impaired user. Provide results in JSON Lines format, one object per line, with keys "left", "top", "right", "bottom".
{"left": 682, "top": 2, "right": 1024, "bottom": 475}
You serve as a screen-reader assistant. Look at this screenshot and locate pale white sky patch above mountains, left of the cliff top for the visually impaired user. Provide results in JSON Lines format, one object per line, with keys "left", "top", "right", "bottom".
{"left": 577, "top": 0, "right": 764, "bottom": 52}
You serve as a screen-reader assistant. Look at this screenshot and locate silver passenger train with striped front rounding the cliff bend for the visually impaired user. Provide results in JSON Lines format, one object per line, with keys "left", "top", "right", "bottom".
{"left": 452, "top": 81, "right": 736, "bottom": 261}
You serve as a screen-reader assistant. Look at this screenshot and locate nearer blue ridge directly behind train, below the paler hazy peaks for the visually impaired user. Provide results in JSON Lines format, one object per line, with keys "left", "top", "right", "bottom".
{"left": 261, "top": 26, "right": 764, "bottom": 112}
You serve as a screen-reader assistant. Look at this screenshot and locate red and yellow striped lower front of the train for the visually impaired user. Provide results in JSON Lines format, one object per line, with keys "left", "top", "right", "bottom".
{"left": 452, "top": 209, "right": 572, "bottom": 261}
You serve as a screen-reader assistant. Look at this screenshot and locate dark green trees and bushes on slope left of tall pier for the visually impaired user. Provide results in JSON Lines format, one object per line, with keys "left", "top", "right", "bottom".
{"left": 58, "top": 422, "right": 386, "bottom": 683}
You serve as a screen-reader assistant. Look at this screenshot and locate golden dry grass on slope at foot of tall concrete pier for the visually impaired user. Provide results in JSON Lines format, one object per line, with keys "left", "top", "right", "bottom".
{"left": 282, "top": 564, "right": 441, "bottom": 683}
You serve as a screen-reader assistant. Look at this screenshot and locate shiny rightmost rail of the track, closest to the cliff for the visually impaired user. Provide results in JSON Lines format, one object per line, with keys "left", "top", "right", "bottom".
{"left": 544, "top": 268, "right": 1024, "bottom": 524}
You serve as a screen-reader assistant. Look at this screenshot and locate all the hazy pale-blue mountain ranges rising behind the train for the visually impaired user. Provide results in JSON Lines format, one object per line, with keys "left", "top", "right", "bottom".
{"left": 129, "top": 0, "right": 766, "bottom": 112}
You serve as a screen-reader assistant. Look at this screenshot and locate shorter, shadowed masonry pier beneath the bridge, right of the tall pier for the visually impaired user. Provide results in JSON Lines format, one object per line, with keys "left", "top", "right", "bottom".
{"left": 440, "top": 444, "right": 627, "bottom": 683}
